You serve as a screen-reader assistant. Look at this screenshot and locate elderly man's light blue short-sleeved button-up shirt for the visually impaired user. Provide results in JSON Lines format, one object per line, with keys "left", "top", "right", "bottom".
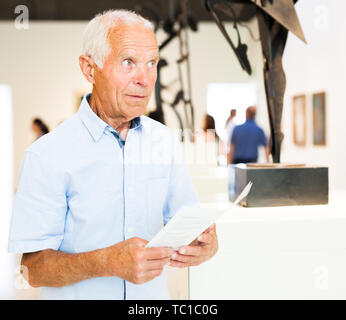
{"left": 8, "top": 95, "right": 198, "bottom": 300}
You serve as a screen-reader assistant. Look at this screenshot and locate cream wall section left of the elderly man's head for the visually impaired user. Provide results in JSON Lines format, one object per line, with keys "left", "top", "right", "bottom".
{"left": 0, "top": 22, "right": 89, "bottom": 185}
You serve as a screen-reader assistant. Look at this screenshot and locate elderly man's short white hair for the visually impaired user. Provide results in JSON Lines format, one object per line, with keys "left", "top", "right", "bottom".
{"left": 83, "top": 10, "right": 153, "bottom": 69}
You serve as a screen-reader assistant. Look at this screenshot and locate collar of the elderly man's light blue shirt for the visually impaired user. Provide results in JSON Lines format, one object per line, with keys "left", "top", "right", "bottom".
{"left": 78, "top": 93, "right": 142, "bottom": 142}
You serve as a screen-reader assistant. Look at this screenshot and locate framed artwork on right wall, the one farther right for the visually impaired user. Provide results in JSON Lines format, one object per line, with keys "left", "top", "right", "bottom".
{"left": 312, "top": 92, "right": 327, "bottom": 146}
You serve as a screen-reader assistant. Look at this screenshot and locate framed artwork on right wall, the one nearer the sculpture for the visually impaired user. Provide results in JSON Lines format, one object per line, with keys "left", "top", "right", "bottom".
{"left": 292, "top": 95, "right": 306, "bottom": 146}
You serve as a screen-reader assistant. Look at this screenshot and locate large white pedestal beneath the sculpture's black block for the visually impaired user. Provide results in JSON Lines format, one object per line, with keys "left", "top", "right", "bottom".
{"left": 189, "top": 190, "right": 346, "bottom": 300}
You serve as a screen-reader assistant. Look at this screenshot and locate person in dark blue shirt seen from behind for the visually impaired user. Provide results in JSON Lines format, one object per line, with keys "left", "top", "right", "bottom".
{"left": 227, "top": 106, "right": 269, "bottom": 164}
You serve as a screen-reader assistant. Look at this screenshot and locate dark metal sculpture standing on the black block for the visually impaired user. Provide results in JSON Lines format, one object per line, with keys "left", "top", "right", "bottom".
{"left": 205, "top": 0, "right": 306, "bottom": 162}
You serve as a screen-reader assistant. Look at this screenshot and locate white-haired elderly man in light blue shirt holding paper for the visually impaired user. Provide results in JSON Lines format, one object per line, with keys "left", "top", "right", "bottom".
{"left": 9, "top": 10, "right": 217, "bottom": 299}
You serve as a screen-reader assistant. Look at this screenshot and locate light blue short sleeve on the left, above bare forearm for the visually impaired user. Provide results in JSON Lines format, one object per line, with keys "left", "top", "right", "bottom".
{"left": 8, "top": 151, "right": 67, "bottom": 253}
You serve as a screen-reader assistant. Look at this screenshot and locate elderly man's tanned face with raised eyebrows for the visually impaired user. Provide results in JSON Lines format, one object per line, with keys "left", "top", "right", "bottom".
{"left": 94, "top": 24, "right": 159, "bottom": 121}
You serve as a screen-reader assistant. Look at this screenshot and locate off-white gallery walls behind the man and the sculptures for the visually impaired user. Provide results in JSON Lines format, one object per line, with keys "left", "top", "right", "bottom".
{"left": 0, "top": 0, "right": 346, "bottom": 188}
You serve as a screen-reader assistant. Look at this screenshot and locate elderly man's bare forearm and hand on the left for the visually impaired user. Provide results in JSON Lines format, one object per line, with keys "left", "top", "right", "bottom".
{"left": 21, "top": 238, "right": 174, "bottom": 287}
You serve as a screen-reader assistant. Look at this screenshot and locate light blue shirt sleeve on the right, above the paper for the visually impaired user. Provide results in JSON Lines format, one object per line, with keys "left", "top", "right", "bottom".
{"left": 163, "top": 134, "right": 199, "bottom": 224}
